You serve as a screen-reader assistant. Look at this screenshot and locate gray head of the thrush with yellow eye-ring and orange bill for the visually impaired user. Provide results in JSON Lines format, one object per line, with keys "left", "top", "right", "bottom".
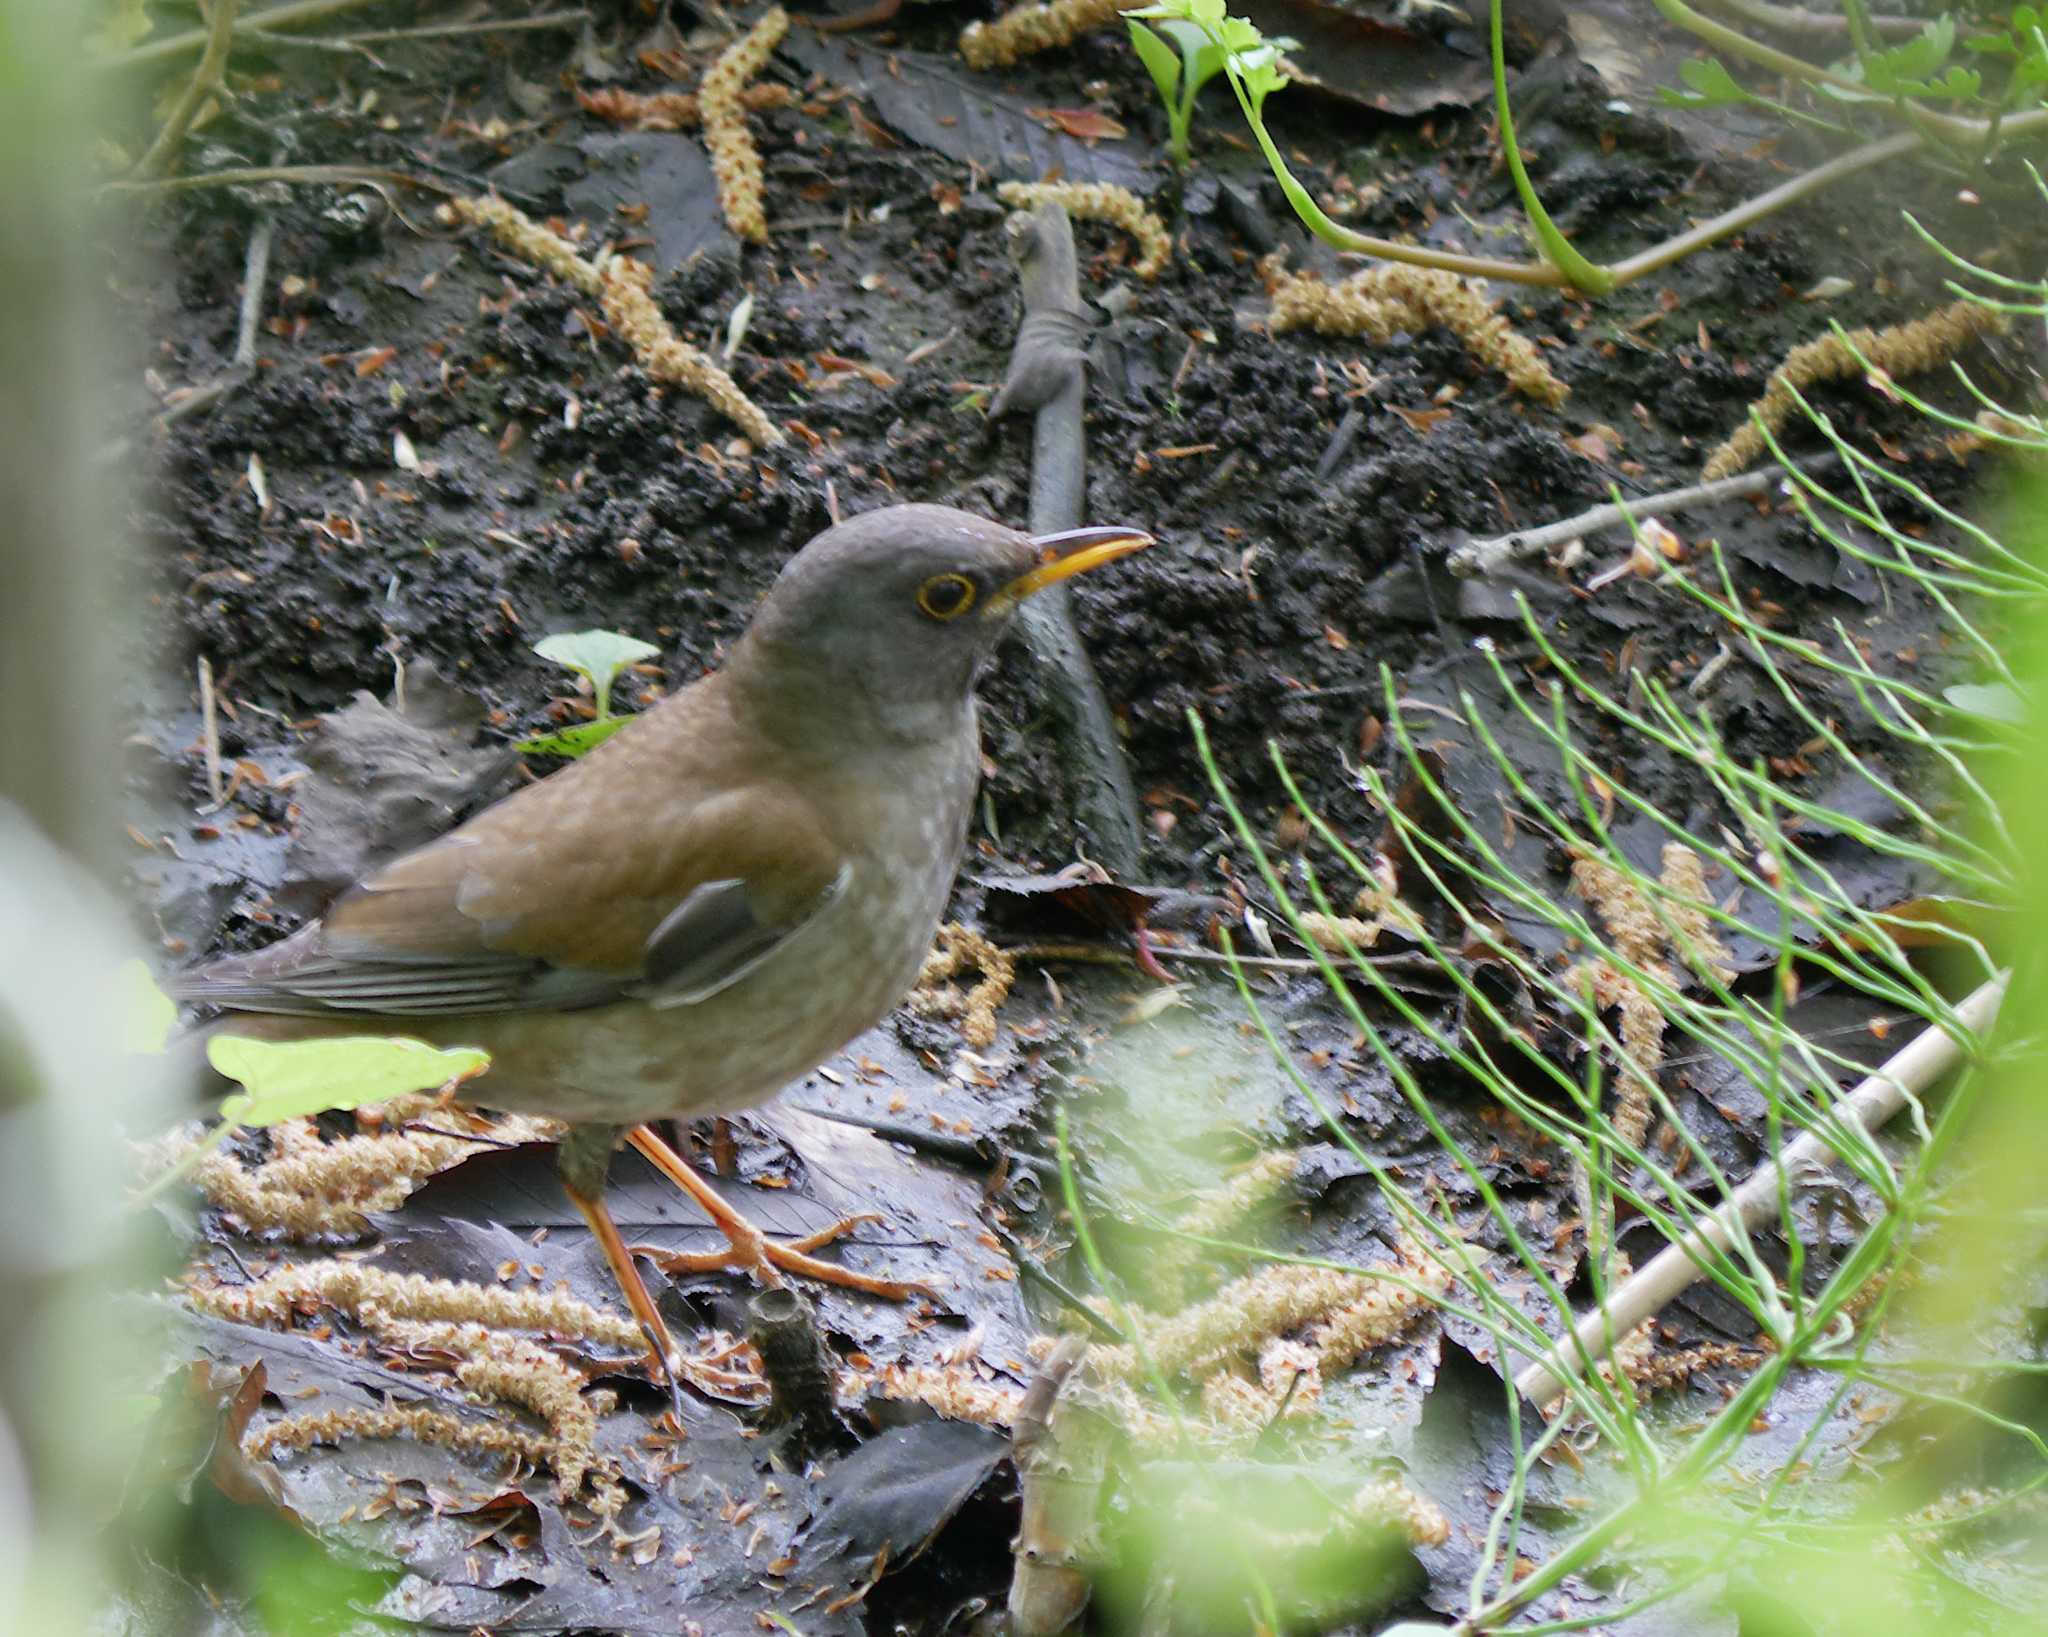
{"left": 733, "top": 506, "right": 1151, "bottom": 738}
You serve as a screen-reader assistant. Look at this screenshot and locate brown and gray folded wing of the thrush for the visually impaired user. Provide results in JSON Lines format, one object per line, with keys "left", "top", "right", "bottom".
{"left": 186, "top": 768, "right": 848, "bottom": 1016}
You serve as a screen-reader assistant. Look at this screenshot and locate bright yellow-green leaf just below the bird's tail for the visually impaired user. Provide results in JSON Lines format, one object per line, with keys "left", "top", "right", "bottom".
{"left": 207, "top": 1035, "right": 492, "bottom": 1125}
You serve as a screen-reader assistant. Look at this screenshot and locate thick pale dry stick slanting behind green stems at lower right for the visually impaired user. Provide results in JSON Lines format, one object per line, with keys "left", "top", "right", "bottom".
{"left": 1516, "top": 971, "right": 2011, "bottom": 1408}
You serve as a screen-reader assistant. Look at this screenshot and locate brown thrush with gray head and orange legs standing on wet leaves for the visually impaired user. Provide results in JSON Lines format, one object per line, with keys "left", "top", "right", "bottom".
{"left": 168, "top": 506, "right": 1151, "bottom": 1381}
